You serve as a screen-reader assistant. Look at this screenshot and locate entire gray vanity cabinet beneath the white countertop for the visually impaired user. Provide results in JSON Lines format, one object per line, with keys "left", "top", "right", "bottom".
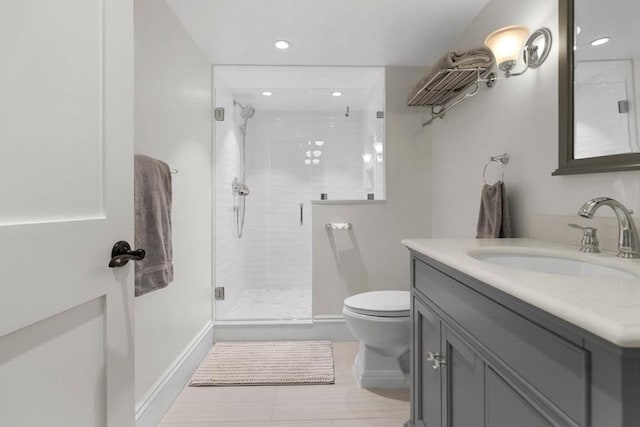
{"left": 407, "top": 253, "right": 640, "bottom": 427}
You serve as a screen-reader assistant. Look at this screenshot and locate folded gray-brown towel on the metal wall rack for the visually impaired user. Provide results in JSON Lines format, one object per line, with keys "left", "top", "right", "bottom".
{"left": 407, "top": 47, "right": 493, "bottom": 104}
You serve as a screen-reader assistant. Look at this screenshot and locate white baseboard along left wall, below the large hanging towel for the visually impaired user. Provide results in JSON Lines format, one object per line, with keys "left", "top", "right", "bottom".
{"left": 136, "top": 321, "right": 213, "bottom": 427}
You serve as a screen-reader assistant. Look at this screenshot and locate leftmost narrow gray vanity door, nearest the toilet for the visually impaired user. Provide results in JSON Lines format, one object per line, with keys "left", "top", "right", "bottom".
{"left": 411, "top": 297, "right": 442, "bottom": 427}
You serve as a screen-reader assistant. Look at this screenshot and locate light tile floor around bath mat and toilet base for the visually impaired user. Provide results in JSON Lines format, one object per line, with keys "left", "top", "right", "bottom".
{"left": 159, "top": 342, "right": 409, "bottom": 427}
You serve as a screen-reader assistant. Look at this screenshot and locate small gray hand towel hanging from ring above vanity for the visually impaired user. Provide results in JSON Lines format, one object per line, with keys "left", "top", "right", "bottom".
{"left": 476, "top": 181, "right": 511, "bottom": 239}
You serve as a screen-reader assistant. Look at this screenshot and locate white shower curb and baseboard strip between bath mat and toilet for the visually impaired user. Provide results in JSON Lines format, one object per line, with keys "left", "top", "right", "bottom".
{"left": 214, "top": 315, "right": 356, "bottom": 342}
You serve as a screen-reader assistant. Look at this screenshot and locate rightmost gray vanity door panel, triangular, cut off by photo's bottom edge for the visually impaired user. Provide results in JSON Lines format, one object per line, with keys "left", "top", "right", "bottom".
{"left": 486, "top": 368, "right": 555, "bottom": 427}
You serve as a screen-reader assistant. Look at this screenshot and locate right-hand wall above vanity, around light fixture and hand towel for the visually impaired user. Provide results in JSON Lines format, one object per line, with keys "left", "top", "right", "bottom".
{"left": 424, "top": 0, "right": 640, "bottom": 241}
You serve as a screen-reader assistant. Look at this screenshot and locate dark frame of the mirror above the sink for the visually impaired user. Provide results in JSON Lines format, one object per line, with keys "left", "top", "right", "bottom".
{"left": 552, "top": 0, "right": 640, "bottom": 175}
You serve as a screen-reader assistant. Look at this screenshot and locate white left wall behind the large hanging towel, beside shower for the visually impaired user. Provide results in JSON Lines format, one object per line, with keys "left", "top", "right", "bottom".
{"left": 135, "top": 0, "right": 212, "bottom": 401}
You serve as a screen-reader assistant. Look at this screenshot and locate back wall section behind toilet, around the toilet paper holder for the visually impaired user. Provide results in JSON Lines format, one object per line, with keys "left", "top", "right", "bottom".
{"left": 313, "top": 67, "right": 431, "bottom": 316}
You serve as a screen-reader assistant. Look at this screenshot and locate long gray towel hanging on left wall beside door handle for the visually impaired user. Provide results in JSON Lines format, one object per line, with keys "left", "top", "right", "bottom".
{"left": 134, "top": 154, "right": 173, "bottom": 296}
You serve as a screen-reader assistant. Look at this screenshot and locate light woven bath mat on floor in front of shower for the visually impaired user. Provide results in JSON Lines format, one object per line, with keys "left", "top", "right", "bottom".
{"left": 189, "top": 341, "right": 335, "bottom": 386}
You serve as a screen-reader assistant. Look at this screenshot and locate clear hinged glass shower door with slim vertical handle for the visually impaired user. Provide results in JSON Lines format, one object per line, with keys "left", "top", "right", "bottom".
{"left": 215, "top": 89, "right": 314, "bottom": 321}
